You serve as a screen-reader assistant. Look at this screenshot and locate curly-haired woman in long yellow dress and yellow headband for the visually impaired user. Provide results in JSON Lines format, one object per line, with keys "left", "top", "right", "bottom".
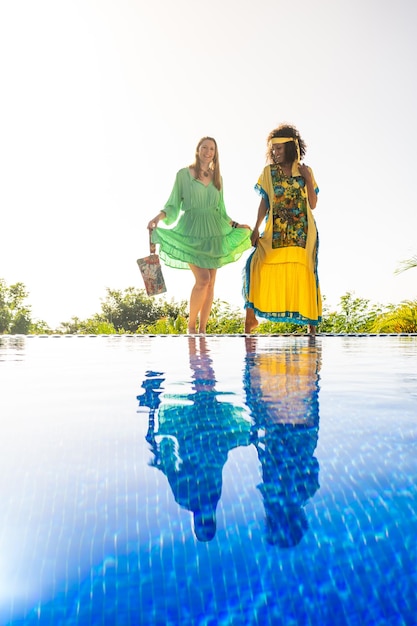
{"left": 244, "top": 124, "right": 322, "bottom": 335}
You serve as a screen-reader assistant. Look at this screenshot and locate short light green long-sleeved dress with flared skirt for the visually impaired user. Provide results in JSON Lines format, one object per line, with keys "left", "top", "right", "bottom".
{"left": 152, "top": 167, "right": 251, "bottom": 269}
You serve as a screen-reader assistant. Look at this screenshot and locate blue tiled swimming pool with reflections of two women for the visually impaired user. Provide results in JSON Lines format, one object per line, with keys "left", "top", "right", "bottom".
{"left": 0, "top": 336, "right": 417, "bottom": 626}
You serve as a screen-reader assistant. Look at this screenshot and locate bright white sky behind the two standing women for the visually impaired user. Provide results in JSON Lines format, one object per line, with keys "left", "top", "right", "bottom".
{"left": 0, "top": 0, "right": 417, "bottom": 327}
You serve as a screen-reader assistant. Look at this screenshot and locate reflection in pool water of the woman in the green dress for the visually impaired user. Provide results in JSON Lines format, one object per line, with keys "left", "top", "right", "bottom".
{"left": 140, "top": 337, "right": 250, "bottom": 541}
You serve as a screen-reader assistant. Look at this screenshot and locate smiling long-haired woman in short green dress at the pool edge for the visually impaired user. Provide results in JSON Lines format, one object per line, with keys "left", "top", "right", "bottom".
{"left": 148, "top": 137, "right": 252, "bottom": 334}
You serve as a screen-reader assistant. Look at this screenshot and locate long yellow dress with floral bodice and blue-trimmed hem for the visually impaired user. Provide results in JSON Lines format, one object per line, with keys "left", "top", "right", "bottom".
{"left": 244, "top": 165, "right": 322, "bottom": 325}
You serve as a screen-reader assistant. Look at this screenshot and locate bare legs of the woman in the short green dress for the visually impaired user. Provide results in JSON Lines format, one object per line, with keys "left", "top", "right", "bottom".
{"left": 188, "top": 263, "right": 217, "bottom": 334}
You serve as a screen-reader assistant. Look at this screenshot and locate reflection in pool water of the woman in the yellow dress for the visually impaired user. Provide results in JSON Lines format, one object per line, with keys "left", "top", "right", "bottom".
{"left": 244, "top": 337, "right": 320, "bottom": 548}
